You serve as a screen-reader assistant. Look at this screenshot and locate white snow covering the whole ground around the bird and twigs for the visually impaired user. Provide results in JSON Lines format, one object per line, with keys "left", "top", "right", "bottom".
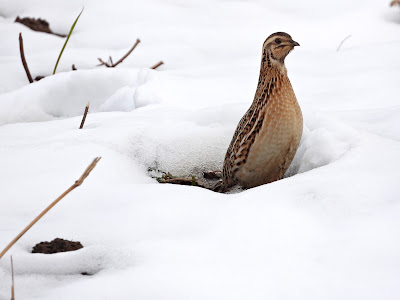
{"left": 0, "top": 0, "right": 400, "bottom": 300}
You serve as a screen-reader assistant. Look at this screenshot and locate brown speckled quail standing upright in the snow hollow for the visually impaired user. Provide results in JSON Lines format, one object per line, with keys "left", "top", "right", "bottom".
{"left": 222, "top": 32, "right": 303, "bottom": 191}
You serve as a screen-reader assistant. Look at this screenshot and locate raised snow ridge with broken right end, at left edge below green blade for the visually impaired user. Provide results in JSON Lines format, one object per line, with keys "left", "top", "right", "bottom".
{"left": 0, "top": 69, "right": 160, "bottom": 125}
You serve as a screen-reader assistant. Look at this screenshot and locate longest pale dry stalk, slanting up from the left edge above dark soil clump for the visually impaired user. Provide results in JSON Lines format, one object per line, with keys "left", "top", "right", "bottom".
{"left": 0, "top": 157, "right": 101, "bottom": 259}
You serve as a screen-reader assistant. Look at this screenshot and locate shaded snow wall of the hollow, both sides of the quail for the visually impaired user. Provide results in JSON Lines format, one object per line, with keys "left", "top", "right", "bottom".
{"left": 123, "top": 105, "right": 359, "bottom": 177}
